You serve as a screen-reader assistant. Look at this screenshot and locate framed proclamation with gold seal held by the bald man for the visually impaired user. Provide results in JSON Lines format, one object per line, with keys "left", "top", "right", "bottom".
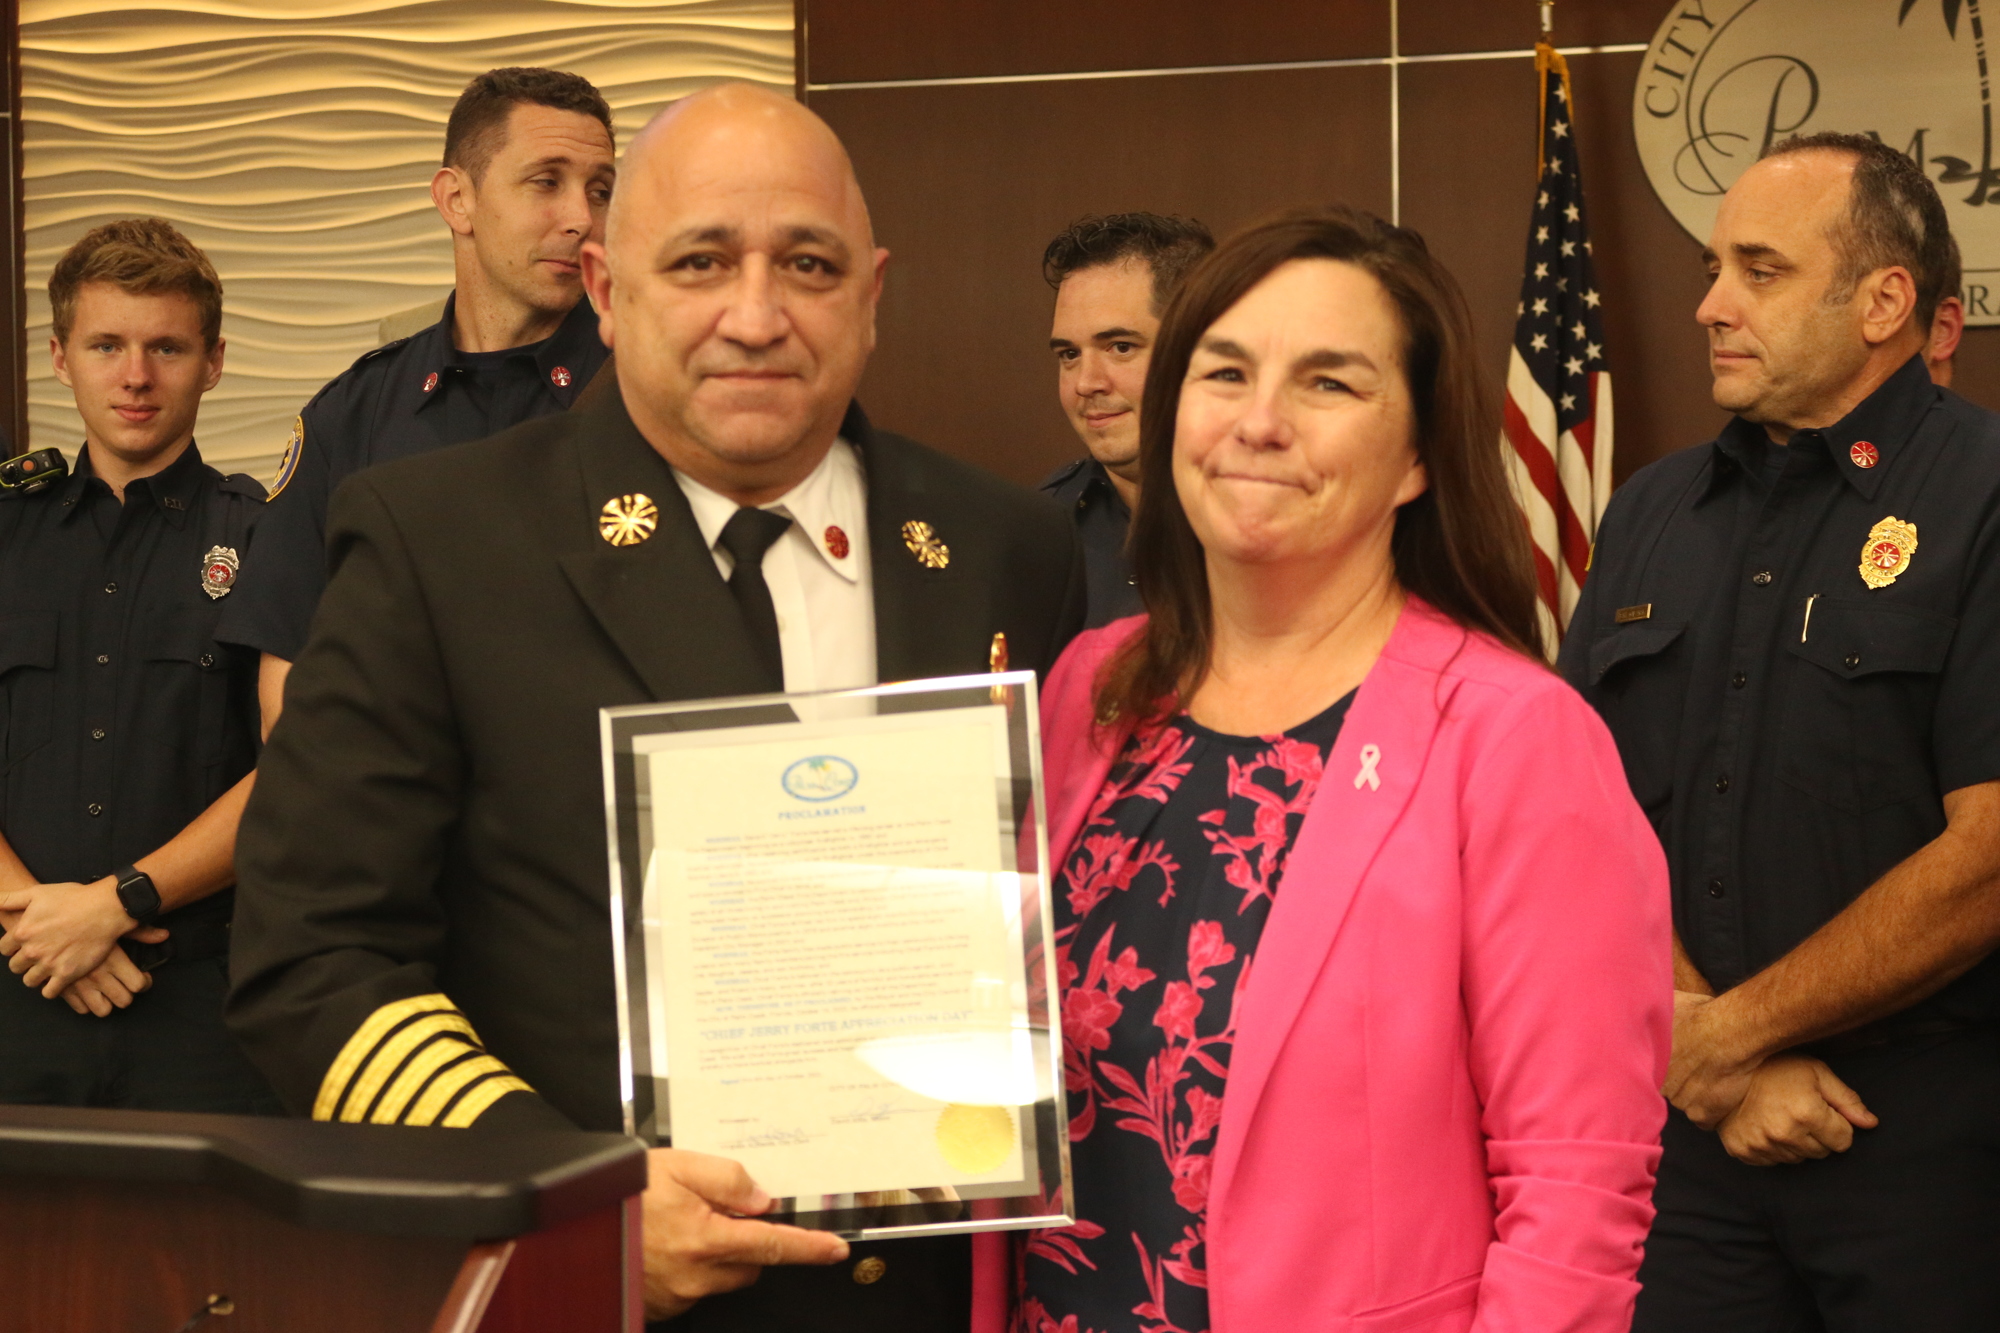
{"left": 602, "top": 671, "right": 1072, "bottom": 1237}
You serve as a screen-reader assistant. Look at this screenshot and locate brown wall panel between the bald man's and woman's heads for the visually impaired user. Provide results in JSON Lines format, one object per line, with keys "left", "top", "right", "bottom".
{"left": 812, "top": 66, "right": 1388, "bottom": 482}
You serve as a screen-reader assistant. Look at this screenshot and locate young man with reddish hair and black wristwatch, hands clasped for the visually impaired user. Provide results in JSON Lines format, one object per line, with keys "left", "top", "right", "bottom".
{"left": 0, "top": 218, "right": 280, "bottom": 1113}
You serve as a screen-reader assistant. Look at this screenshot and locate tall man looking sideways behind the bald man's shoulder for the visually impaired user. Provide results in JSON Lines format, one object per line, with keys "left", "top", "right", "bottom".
{"left": 220, "top": 68, "right": 614, "bottom": 731}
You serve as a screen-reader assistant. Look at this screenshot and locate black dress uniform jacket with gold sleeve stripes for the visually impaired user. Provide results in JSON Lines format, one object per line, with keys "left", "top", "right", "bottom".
{"left": 230, "top": 394, "right": 1084, "bottom": 1329}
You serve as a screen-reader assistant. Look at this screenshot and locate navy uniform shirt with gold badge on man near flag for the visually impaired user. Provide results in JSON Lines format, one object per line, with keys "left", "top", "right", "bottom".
{"left": 1562, "top": 358, "right": 2000, "bottom": 1023}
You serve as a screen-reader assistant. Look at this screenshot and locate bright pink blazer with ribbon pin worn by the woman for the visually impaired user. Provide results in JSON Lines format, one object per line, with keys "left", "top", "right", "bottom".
{"left": 974, "top": 598, "right": 1672, "bottom": 1333}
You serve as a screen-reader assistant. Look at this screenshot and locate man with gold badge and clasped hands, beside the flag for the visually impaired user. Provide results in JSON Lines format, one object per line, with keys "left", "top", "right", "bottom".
{"left": 1562, "top": 134, "right": 2000, "bottom": 1333}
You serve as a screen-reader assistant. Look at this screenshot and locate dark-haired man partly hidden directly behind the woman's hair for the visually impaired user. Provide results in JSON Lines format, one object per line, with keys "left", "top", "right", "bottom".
{"left": 1042, "top": 212, "right": 1216, "bottom": 628}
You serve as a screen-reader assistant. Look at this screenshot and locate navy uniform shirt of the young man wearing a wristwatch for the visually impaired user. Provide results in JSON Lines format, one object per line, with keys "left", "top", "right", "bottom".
{"left": 0, "top": 444, "right": 264, "bottom": 927}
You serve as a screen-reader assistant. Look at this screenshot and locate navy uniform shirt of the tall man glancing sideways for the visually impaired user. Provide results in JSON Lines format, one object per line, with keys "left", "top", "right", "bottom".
{"left": 220, "top": 294, "right": 608, "bottom": 662}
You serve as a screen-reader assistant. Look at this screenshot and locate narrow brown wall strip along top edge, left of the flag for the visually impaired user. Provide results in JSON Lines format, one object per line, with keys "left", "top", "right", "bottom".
{"left": 802, "top": 0, "right": 1388, "bottom": 84}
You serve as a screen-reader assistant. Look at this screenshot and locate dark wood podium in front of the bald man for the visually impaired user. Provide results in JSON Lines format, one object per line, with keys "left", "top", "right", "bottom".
{"left": 0, "top": 1107, "right": 646, "bottom": 1333}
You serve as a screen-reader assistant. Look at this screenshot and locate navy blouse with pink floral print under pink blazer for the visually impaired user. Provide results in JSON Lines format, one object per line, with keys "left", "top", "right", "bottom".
{"left": 1014, "top": 695, "right": 1354, "bottom": 1333}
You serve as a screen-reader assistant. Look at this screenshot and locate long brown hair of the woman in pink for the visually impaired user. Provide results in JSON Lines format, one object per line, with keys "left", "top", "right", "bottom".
{"left": 1096, "top": 208, "right": 1542, "bottom": 723}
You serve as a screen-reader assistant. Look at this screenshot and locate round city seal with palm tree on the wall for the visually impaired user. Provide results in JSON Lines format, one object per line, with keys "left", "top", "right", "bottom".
{"left": 1632, "top": 0, "right": 2000, "bottom": 324}
